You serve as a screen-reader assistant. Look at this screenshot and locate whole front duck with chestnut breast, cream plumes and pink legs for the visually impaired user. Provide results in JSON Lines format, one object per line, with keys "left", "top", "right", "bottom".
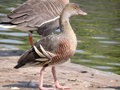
{"left": 15, "top": 3, "right": 87, "bottom": 90}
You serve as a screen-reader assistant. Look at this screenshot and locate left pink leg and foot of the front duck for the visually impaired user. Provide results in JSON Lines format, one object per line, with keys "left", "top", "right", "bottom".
{"left": 39, "top": 67, "right": 54, "bottom": 90}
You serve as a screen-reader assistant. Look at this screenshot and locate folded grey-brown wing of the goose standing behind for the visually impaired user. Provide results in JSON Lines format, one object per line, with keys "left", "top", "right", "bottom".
{"left": 8, "top": 0, "right": 64, "bottom": 27}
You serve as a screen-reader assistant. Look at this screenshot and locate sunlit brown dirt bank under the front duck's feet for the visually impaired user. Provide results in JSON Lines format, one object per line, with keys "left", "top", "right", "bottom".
{"left": 0, "top": 49, "right": 120, "bottom": 90}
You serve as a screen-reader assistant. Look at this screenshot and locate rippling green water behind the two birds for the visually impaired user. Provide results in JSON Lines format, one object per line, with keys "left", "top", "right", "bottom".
{"left": 0, "top": 0, "right": 120, "bottom": 75}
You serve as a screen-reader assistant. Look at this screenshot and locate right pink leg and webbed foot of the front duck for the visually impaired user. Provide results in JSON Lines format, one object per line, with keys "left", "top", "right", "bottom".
{"left": 52, "top": 66, "right": 71, "bottom": 89}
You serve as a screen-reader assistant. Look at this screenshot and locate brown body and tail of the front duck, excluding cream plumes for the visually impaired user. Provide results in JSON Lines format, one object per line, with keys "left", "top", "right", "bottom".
{"left": 15, "top": 34, "right": 76, "bottom": 69}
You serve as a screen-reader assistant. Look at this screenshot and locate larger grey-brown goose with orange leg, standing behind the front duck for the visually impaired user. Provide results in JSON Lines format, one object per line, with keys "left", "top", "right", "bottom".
{"left": 0, "top": 0, "right": 69, "bottom": 45}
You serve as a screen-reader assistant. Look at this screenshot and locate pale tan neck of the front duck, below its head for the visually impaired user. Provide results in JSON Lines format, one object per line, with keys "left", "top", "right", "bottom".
{"left": 60, "top": 10, "right": 77, "bottom": 51}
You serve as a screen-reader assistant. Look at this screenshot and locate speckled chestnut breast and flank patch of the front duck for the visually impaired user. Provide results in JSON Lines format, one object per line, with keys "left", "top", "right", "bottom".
{"left": 50, "top": 38, "right": 75, "bottom": 65}
